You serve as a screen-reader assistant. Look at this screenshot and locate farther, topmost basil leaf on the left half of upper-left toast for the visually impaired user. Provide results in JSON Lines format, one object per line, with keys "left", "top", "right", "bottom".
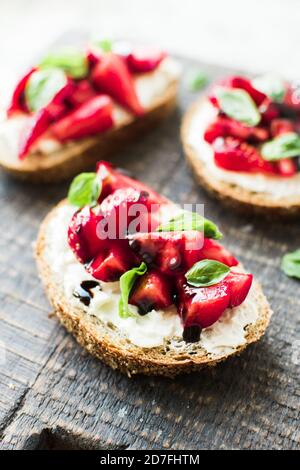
{"left": 40, "top": 47, "right": 89, "bottom": 79}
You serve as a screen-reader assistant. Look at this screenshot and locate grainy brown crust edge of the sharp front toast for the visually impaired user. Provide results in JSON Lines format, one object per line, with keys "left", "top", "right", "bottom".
{"left": 35, "top": 201, "right": 272, "bottom": 377}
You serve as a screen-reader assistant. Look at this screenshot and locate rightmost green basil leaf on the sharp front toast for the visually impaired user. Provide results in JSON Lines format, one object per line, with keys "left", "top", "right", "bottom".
{"left": 185, "top": 259, "right": 230, "bottom": 287}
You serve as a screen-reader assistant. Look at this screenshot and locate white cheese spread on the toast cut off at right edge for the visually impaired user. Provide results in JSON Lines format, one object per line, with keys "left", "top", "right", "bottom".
{"left": 187, "top": 101, "right": 300, "bottom": 199}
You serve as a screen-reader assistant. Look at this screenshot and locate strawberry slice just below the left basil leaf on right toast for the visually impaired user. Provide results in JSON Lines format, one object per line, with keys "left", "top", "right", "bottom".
{"left": 204, "top": 117, "right": 269, "bottom": 144}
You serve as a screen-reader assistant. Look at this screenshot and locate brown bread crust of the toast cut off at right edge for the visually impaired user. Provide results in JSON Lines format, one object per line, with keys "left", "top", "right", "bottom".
{"left": 181, "top": 98, "right": 300, "bottom": 218}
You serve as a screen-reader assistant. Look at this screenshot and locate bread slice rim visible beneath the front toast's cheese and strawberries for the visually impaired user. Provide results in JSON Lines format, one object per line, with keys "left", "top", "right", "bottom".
{"left": 36, "top": 201, "right": 272, "bottom": 377}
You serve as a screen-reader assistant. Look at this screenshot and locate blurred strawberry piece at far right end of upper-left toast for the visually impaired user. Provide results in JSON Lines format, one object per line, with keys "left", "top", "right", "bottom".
{"left": 127, "top": 46, "right": 166, "bottom": 73}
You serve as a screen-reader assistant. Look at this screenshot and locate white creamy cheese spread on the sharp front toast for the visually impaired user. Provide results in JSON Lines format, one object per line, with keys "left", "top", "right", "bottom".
{"left": 46, "top": 205, "right": 258, "bottom": 354}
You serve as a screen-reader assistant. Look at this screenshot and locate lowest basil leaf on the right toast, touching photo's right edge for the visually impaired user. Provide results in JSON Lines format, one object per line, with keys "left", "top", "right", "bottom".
{"left": 261, "top": 132, "right": 300, "bottom": 161}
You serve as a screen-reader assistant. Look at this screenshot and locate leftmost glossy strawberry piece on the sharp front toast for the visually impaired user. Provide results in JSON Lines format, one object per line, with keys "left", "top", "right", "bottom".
{"left": 68, "top": 206, "right": 106, "bottom": 263}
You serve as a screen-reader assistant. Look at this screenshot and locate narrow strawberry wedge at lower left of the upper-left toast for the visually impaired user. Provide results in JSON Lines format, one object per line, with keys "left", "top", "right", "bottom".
{"left": 18, "top": 109, "right": 52, "bottom": 160}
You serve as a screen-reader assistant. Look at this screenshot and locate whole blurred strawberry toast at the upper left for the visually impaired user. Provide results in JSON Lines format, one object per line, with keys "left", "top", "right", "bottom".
{"left": 0, "top": 41, "right": 179, "bottom": 182}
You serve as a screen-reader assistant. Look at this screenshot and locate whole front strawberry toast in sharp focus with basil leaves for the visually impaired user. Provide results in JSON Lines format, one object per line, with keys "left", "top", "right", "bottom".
{"left": 36, "top": 162, "right": 271, "bottom": 376}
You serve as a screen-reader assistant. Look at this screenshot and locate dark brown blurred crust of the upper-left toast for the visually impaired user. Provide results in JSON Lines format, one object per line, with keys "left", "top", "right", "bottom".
{"left": 0, "top": 79, "right": 178, "bottom": 183}
